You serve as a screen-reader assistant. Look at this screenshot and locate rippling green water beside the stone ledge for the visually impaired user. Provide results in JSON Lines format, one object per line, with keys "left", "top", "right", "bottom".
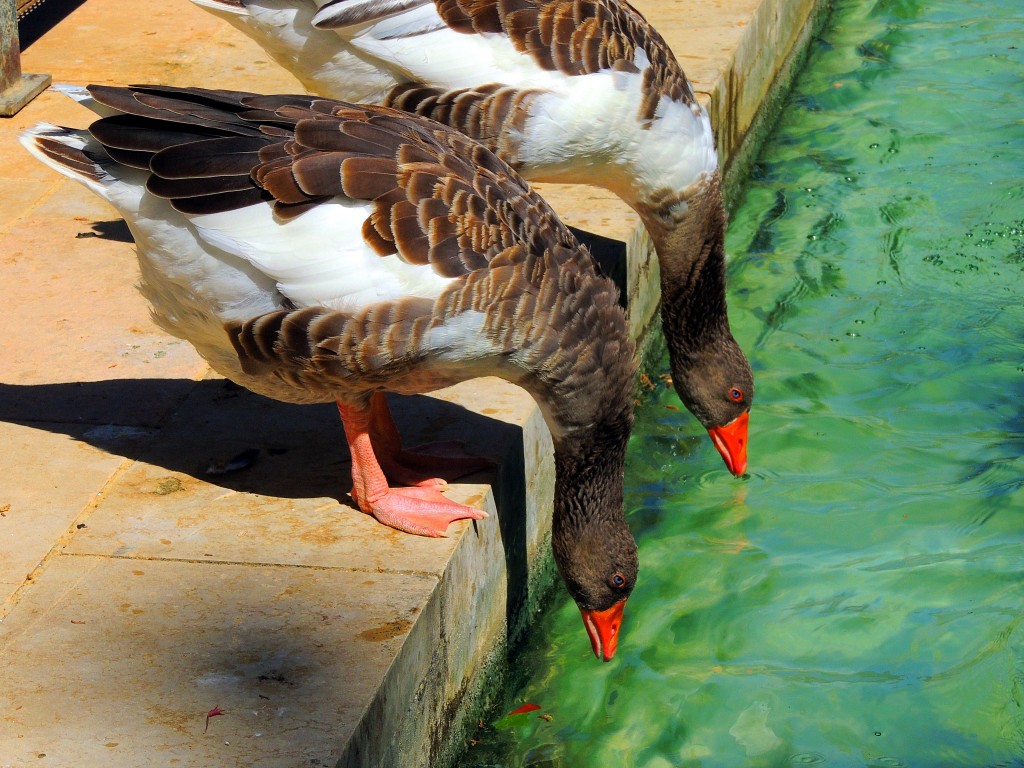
{"left": 463, "top": 0, "right": 1024, "bottom": 768}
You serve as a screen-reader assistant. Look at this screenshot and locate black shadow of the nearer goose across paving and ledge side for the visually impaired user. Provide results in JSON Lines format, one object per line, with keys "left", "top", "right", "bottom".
{"left": 0, "top": 378, "right": 530, "bottom": 643}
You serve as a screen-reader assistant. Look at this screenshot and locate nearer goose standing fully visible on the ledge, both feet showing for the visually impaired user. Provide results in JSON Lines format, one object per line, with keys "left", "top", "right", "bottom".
{"left": 23, "top": 86, "right": 638, "bottom": 660}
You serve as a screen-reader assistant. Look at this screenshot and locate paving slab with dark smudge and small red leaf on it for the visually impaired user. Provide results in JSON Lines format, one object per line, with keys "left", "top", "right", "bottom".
{"left": 0, "top": 556, "right": 437, "bottom": 768}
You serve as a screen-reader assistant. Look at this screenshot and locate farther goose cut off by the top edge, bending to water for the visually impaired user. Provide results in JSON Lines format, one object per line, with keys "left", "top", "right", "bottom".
{"left": 194, "top": 0, "right": 754, "bottom": 475}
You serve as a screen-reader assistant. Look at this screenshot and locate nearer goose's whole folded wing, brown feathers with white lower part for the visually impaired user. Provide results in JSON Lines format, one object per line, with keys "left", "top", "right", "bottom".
{"left": 83, "top": 86, "right": 578, "bottom": 308}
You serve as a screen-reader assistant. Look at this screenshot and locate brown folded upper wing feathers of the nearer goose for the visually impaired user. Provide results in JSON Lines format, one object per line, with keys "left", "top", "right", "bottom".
{"left": 83, "top": 86, "right": 575, "bottom": 276}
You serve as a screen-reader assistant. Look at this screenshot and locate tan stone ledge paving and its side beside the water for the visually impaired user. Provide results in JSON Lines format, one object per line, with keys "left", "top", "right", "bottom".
{"left": 0, "top": 0, "right": 816, "bottom": 768}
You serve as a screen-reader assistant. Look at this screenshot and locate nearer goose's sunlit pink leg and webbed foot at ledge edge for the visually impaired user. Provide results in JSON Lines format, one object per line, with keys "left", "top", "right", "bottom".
{"left": 338, "top": 402, "right": 487, "bottom": 537}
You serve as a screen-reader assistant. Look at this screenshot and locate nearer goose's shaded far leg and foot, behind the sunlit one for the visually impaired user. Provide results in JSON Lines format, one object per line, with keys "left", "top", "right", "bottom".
{"left": 370, "top": 392, "right": 495, "bottom": 486}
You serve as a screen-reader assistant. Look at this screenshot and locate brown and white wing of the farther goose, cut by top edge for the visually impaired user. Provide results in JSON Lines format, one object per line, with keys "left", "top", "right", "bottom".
{"left": 313, "top": 0, "right": 695, "bottom": 119}
